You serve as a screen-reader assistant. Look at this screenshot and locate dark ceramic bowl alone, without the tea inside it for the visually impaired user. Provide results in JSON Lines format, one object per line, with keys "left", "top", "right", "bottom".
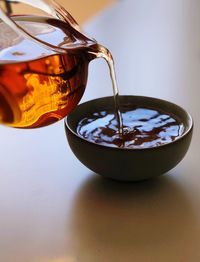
{"left": 65, "top": 96, "right": 193, "bottom": 181}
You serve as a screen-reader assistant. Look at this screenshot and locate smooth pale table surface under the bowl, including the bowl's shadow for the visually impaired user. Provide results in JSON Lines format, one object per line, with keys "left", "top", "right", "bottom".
{"left": 0, "top": 0, "right": 200, "bottom": 262}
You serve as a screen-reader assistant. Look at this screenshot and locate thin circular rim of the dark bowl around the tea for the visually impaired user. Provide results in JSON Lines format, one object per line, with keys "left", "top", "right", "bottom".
{"left": 64, "top": 95, "right": 194, "bottom": 151}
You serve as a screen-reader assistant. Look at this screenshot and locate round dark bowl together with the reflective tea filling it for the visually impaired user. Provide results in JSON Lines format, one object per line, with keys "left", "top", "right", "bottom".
{"left": 65, "top": 96, "right": 193, "bottom": 181}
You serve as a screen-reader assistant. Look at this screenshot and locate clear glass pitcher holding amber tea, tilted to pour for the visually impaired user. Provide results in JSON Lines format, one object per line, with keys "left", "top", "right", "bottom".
{"left": 0, "top": 0, "right": 109, "bottom": 128}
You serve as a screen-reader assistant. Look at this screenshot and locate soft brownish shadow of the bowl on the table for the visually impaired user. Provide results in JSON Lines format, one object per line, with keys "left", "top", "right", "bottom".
{"left": 70, "top": 174, "right": 195, "bottom": 262}
